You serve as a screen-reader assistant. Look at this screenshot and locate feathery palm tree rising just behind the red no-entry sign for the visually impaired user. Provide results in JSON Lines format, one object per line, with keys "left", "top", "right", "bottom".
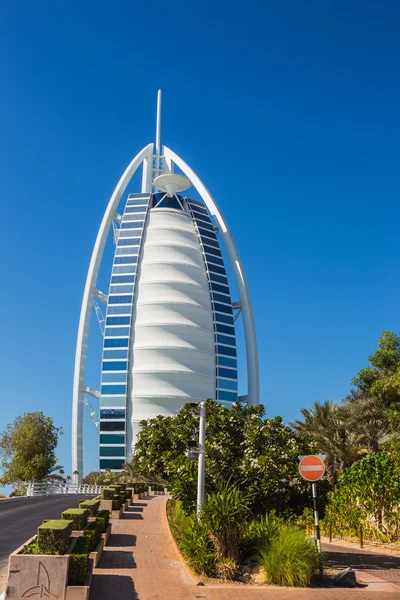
{"left": 291, "top": 400, "right": 359, "bottom": 484}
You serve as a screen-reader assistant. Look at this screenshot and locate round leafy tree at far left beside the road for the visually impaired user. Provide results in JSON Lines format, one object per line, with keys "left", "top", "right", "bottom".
{"left": 0, "top": 412, "right": 64, "bottom": 488}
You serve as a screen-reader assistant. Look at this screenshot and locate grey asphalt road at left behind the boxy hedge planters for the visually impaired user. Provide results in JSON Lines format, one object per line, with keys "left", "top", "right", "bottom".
{"left": 0, "top": 494, "right": 93, "bottom": 580}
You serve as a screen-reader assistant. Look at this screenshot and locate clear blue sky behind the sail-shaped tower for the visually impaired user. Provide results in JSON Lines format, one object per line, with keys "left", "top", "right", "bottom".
{"left": 0, "top": 0, "right": 400, "bottom": 480}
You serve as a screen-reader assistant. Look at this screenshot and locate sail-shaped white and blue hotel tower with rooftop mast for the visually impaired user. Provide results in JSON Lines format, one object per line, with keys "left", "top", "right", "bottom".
{"left": 72, "top": 92, "right": 259, "bottom": 481}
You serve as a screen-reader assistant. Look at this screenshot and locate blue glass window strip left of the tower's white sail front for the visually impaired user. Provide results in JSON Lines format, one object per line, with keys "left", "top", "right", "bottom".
{"left": 99, "top": 194, "right": 151, "bottom": 470}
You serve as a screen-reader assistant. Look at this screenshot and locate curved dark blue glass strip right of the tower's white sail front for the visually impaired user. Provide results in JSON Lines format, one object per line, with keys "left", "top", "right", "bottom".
{"left": 186, "top": 198, "right": 237, "bottom": 405}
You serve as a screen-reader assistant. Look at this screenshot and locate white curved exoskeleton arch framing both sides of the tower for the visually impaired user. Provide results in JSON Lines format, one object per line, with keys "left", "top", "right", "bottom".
{"left": 72, "top": 144, "right": 259, "bottom": 483}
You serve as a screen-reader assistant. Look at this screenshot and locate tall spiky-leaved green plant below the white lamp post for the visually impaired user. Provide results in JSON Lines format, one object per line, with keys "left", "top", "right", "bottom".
{"left": 200, "top": 482, "right": 251, "bottom": 563}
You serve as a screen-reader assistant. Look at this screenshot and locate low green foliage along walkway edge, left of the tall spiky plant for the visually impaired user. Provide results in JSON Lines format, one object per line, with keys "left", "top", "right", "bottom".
{"left": 167, "top": 500, "right": 215, "bottom": 575}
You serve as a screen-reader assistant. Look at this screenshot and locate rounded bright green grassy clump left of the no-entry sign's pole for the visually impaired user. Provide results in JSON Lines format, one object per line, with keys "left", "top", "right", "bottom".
{"left": 260, "top": 525, "right": 321, "bottom": 587}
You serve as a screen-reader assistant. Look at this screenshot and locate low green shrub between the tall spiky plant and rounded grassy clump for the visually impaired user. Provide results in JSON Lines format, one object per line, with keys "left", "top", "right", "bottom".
{"left": 239, "top": 513, "right": 280, "bottom": 563}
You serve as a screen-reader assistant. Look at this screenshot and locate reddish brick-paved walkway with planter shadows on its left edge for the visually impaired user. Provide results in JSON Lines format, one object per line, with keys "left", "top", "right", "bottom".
{"left": 90, "top": 496, "right": 400, "bottom": 600}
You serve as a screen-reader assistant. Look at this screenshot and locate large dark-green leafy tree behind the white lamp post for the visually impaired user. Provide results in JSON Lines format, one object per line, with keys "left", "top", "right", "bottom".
{"left": 133, "top": 400, "right": 309, "bottom": 512}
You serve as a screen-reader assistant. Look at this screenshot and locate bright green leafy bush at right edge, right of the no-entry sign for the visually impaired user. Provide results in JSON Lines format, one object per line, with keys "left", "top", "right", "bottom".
{"left": 326, "top": 451, "right": 400, "bottom": 539}
